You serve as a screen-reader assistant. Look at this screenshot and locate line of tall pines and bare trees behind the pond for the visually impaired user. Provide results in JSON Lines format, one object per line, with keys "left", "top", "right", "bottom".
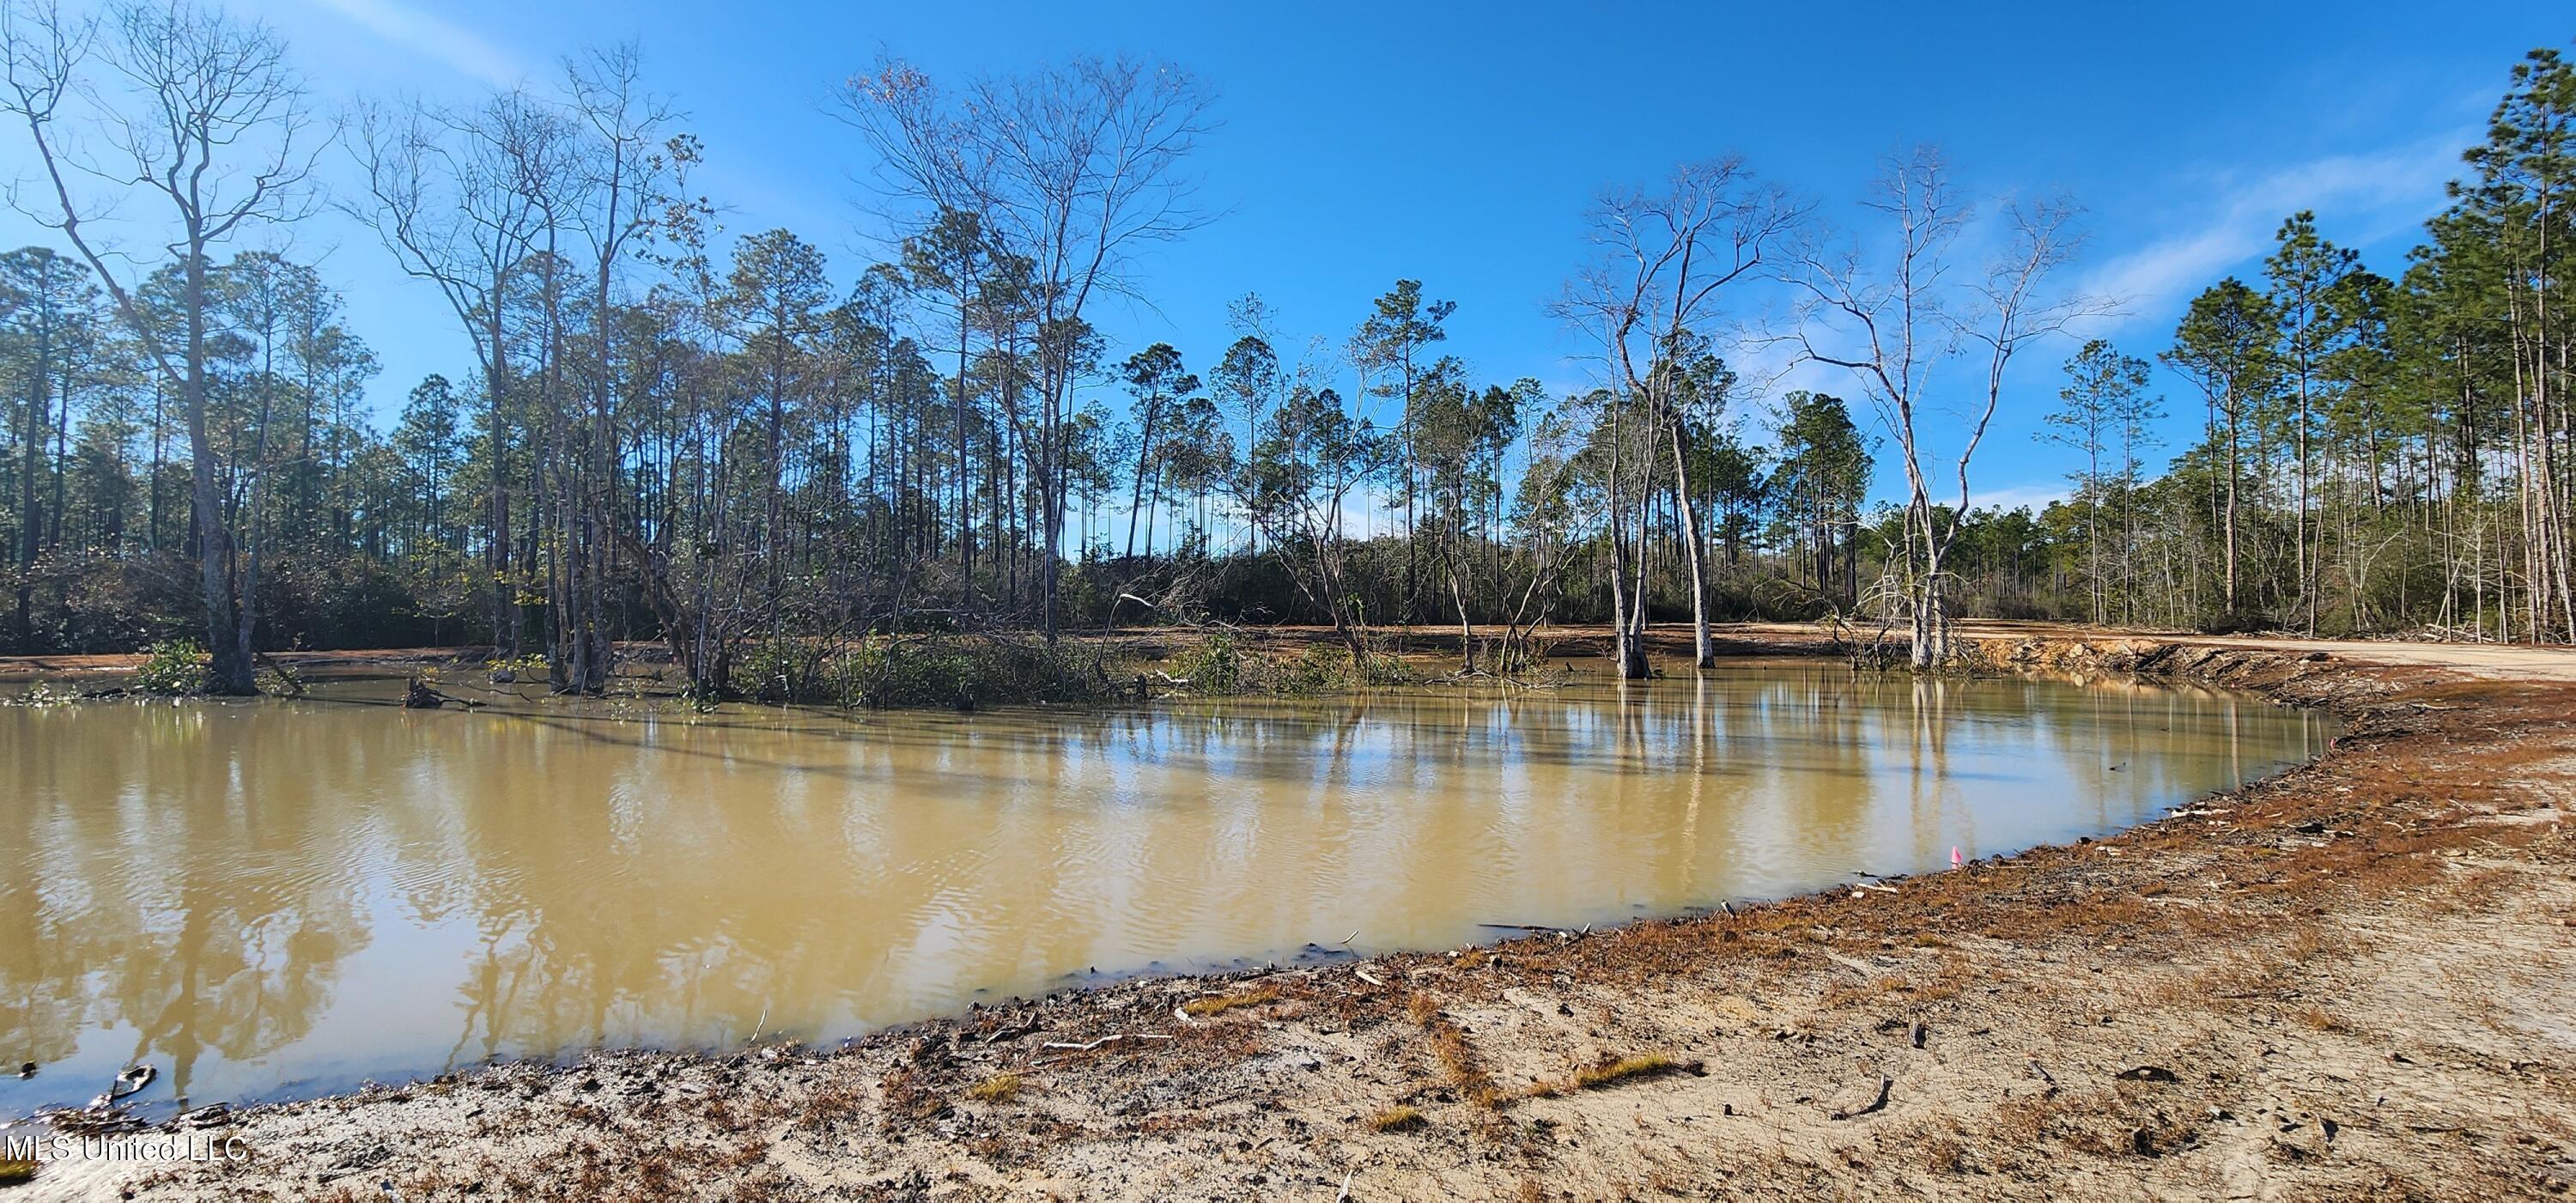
{"left": 0, "top": 0, "right": 2576, "bottom": 696}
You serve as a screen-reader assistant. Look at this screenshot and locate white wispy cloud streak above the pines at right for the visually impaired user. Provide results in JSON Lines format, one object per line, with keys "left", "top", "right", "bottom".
{"left": 2081, "top": 129, "right": 2478, "bottom": 327}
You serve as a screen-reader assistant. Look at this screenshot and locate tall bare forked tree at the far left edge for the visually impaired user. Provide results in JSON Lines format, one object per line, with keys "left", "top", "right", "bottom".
{"left": 0, "top": 5, "right": 312, "bottom": 693}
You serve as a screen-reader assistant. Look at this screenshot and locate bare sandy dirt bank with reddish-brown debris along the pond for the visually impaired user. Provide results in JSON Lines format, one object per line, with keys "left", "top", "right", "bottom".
{"left": 36, "top": 629, "right": 2576, "bottom": 1200}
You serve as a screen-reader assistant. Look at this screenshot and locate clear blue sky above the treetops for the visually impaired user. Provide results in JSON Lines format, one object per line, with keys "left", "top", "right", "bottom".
{"left": 0, "top": 0, "right": 2576, "bottom": 513}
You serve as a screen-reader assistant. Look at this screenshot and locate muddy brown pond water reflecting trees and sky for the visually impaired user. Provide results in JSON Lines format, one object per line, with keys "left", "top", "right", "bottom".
{"left": 0, "top": 659, "right": 2331, "bottom": 1113}
